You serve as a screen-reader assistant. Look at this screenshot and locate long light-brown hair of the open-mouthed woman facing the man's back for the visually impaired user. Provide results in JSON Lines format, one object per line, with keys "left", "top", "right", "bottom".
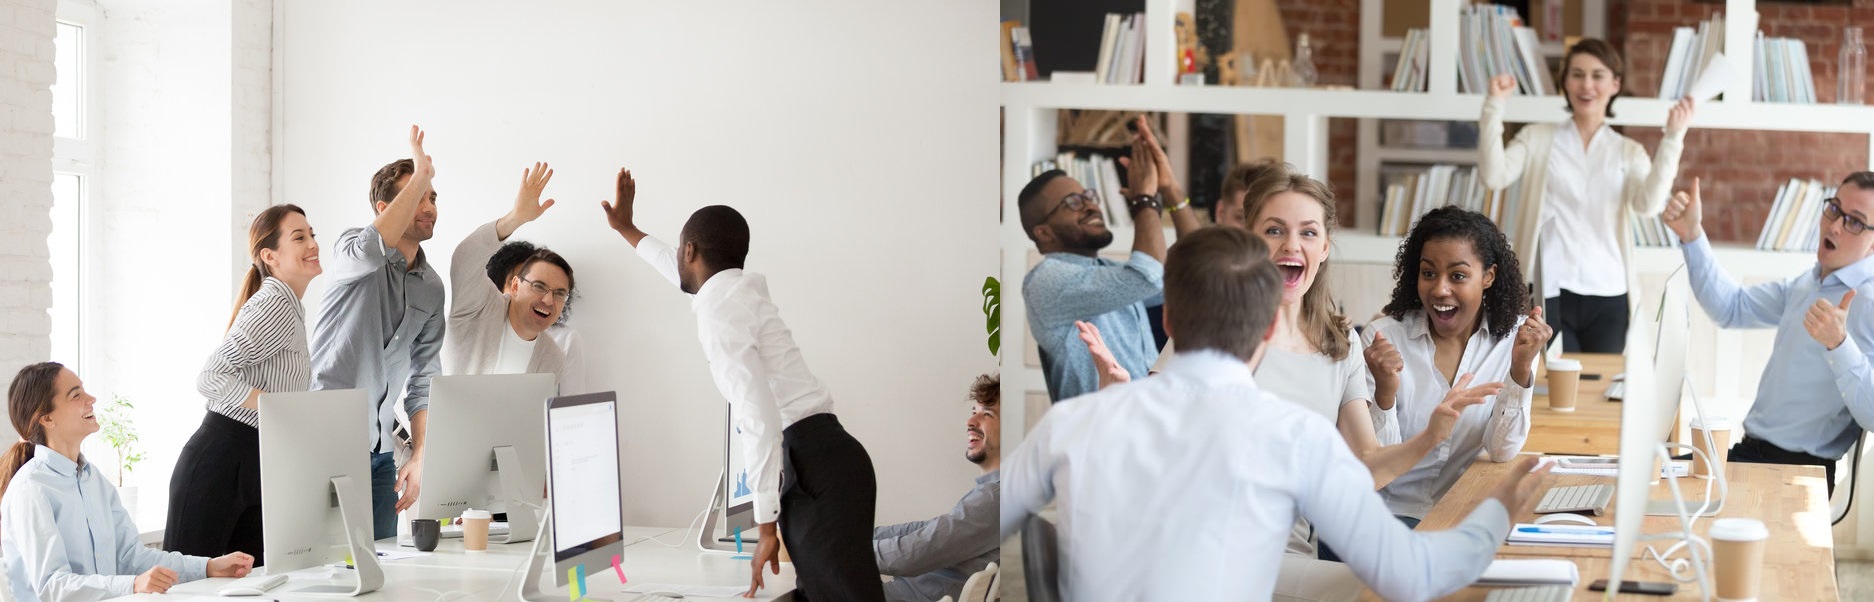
{"left": 1242, "top": 165, "right": 1347, "bottom": 362}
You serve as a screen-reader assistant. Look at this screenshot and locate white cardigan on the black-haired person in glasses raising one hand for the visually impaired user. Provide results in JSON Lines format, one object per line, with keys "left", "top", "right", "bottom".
{"left": 442, "top": 221, "right": 566, "bottom": 383}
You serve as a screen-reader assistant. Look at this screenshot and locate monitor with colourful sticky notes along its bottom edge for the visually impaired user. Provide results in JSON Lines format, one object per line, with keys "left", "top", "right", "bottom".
{"left": 547, "top": 386, "right": 624, "bottom": 585}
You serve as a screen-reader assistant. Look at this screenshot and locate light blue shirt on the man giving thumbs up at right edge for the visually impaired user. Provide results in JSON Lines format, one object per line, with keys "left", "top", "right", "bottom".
{"left": 1685, "top": 236, "right": 1874, "bottom": 458}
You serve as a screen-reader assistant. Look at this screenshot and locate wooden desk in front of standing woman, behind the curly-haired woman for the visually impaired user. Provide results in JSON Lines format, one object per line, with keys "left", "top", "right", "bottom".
{"left": 1524, "top": 353, "right": 1627, "bottom": 456}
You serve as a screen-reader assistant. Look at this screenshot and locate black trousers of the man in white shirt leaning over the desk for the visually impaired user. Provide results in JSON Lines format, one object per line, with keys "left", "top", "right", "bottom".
{"left": 780, "top": 414, "right": 885, "bottom": 602}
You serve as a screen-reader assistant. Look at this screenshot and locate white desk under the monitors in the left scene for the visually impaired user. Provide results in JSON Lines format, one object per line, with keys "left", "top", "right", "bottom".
{"left": 111, "top": 527, "right": 795, "bottom": 602}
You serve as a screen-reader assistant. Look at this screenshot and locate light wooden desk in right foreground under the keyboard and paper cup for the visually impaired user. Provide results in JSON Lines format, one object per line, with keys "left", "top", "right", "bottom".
{"left": 1419, "top": 453, "right": 1838, "bottom": 600}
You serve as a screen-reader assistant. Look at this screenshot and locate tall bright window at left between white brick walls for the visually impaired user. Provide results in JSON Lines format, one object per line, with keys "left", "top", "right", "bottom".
{"left": 45, "top": 0, "right": 97, "bottom": 373}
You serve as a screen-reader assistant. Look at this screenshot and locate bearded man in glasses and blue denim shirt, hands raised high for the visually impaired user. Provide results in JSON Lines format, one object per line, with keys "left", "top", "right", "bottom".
{"left": 1016, "top": 116, "right": 1197, "bottom": 401}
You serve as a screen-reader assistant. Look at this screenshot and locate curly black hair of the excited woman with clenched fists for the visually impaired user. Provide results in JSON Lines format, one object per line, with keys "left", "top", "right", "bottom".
{"left": 1383, "top": 206, "right": 1529, "bottom": 339}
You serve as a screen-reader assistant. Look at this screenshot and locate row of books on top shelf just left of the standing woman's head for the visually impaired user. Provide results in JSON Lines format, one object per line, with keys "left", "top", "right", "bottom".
{"left": 1446, "top": 4, "right": 1555, "bottom": 96}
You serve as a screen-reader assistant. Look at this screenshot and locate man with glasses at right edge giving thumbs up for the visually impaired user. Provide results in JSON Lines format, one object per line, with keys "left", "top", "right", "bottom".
{"left": 1660, "top": 171, "right": 1874, "bottom": 495}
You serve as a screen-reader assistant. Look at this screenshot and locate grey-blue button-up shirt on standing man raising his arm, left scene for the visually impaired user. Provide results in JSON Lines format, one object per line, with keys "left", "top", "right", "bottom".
{"left": 313, "top": 227, "right": 448, "bottom": 452}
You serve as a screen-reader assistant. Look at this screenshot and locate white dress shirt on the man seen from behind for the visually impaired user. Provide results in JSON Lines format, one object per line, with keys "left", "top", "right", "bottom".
{"left": 1001, "top": 351, "right": 1510, "bottom": 600}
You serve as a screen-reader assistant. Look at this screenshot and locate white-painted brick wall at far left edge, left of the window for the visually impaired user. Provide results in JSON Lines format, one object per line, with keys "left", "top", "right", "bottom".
{"left": 0, "top": 0, "right": 58, "bottom": 384}
